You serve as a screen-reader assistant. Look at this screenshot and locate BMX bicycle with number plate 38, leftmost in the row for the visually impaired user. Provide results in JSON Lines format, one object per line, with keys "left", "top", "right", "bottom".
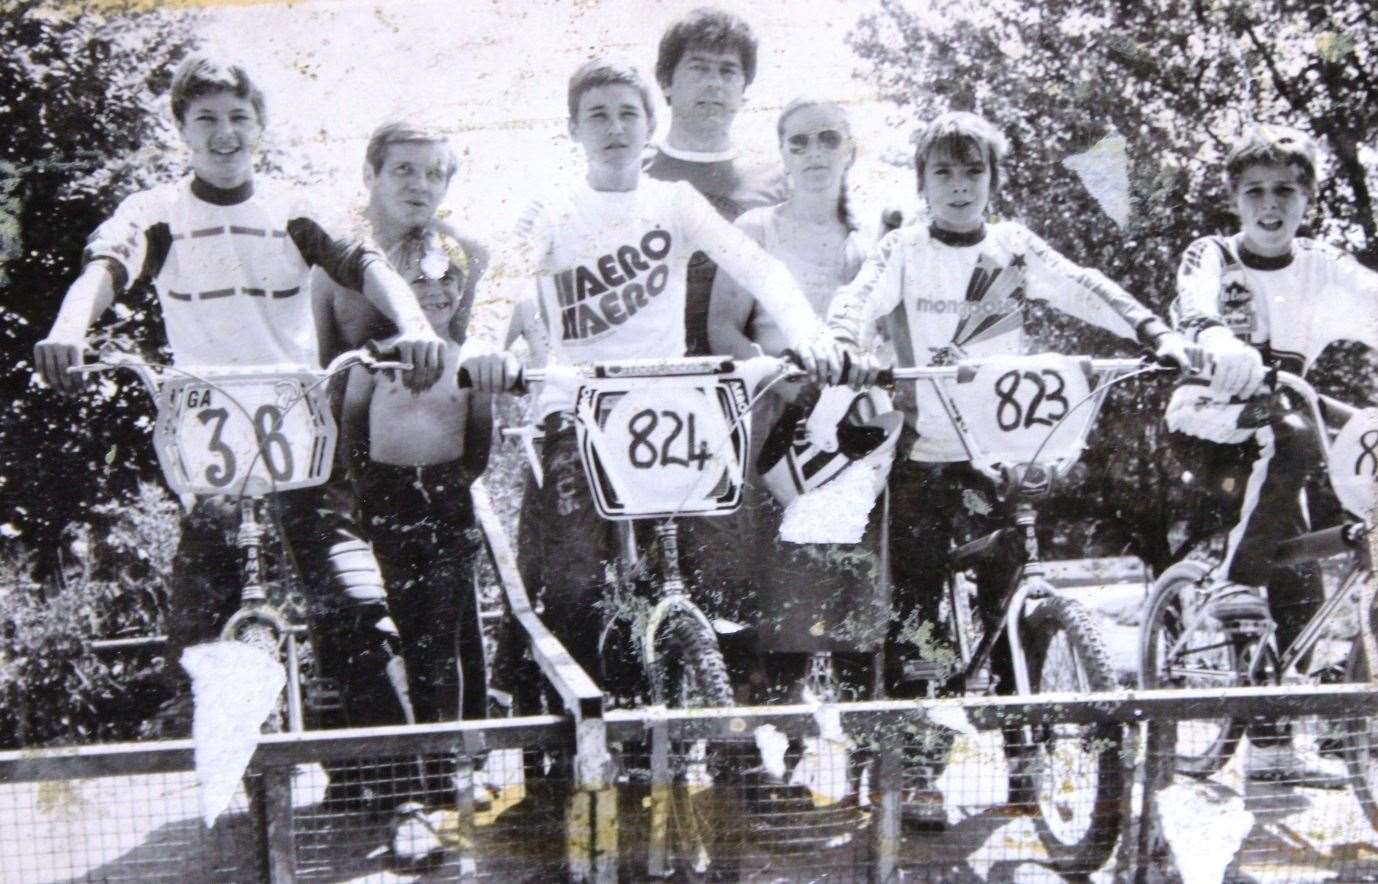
{"left": 69, "top": 337, "right": 411, "bottom": 733}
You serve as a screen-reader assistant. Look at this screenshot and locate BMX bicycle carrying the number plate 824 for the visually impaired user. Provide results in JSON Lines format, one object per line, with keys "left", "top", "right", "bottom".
{"left": 474, "top": 357, "right": 870, "bottom": 878}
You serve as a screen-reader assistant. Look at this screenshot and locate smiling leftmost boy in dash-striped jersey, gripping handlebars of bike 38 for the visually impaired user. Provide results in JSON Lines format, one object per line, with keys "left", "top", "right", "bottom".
{"left": 34, "top": 55, "right": 441, "bottom": 743}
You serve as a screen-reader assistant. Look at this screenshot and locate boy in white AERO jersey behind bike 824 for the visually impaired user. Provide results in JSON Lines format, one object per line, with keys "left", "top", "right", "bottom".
{"left": 464, "top": 59, "right": 839, "bottom": 693}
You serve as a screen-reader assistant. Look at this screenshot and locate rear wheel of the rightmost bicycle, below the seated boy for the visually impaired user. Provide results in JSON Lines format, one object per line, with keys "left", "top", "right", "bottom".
{"left": 1138, "top": 560, "right": 1248, "bottom": 779}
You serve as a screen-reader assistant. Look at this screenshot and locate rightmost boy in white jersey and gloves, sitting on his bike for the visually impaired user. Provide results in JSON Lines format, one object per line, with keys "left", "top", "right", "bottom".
{"left": 1167, "top": 127, "right": 1378, "bottom": 788}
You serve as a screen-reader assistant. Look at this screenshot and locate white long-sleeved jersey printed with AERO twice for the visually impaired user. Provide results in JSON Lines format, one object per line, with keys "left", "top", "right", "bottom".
{"left": 518, "top": 179, "right": 825, "bottom": 416}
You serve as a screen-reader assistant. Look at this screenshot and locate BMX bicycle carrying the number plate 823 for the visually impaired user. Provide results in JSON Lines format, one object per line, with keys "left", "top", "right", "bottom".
{"left": 879, "top": 354, "right": 1159, "bottom": 873}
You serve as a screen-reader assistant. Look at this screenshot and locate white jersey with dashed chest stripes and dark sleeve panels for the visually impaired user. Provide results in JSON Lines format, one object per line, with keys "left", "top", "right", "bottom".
{"left": 85, "top": 178, "right": 380, "bottom": 368}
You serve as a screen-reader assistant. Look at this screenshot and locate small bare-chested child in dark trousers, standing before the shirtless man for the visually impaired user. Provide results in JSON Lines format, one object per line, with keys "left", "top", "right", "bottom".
{"left": 343, "top": 231, "right": 492, "bottom": 837}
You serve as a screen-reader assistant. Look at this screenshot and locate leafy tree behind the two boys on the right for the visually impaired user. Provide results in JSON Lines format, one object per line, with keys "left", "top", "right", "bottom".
{"left": 850, "top": 0, "right": 1378, "bottom": 566}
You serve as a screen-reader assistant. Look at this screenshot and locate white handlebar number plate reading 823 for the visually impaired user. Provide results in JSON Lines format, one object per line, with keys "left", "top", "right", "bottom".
{"left": 943, "top": 354, "right": 1096, "bottom": 472}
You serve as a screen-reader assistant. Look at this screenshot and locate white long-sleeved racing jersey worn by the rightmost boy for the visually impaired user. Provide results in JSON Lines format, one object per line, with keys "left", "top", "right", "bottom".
{"left": 1171, "top": 235, "right": 1378, "bottom": 373}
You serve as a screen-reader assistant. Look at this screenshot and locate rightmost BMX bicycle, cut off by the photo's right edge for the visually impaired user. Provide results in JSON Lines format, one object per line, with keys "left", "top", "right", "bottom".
{"left": 1140, "top": 372, "right": 1378, "bottom": 828}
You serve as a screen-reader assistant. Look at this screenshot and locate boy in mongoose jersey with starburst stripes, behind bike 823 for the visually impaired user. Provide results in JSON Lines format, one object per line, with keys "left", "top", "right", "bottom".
{"left": 828, "top": 112, "right": 1185, "bottom": 825}
